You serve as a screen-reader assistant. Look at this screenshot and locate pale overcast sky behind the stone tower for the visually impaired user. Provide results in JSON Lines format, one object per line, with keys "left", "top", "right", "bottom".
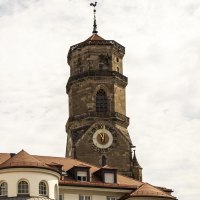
{"left": 0, "top": 0, "right": 200, "bottom": 200}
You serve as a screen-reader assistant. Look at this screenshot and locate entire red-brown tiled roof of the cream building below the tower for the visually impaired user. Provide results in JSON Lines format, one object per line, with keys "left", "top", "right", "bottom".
{"left": 0, "top": 150, "right": 176, "bottom": 200}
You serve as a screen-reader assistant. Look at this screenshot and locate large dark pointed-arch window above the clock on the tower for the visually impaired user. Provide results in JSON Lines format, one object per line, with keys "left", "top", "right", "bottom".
{"left": 96, "top": 89, "right": 108, "bottom": 112}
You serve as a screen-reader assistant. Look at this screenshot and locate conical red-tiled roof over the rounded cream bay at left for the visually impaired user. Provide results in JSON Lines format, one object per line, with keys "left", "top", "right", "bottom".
{"left": 0, "top": 150, "right": 57, "bottom": 171}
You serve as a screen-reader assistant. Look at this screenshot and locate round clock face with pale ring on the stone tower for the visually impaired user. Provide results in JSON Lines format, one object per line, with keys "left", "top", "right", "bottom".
{"left": 90, "top": 124, "right": 116, "bottom": 153}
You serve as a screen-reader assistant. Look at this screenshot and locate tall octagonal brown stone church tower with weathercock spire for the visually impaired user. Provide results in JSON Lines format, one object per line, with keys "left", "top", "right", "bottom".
{"left": 66, "top": 3, "right": 142, "bottom": 180}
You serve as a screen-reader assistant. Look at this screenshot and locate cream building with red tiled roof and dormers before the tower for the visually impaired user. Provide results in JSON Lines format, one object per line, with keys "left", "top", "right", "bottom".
{"left": 0, "top": 150, "right": 176, "bottom": 200}
